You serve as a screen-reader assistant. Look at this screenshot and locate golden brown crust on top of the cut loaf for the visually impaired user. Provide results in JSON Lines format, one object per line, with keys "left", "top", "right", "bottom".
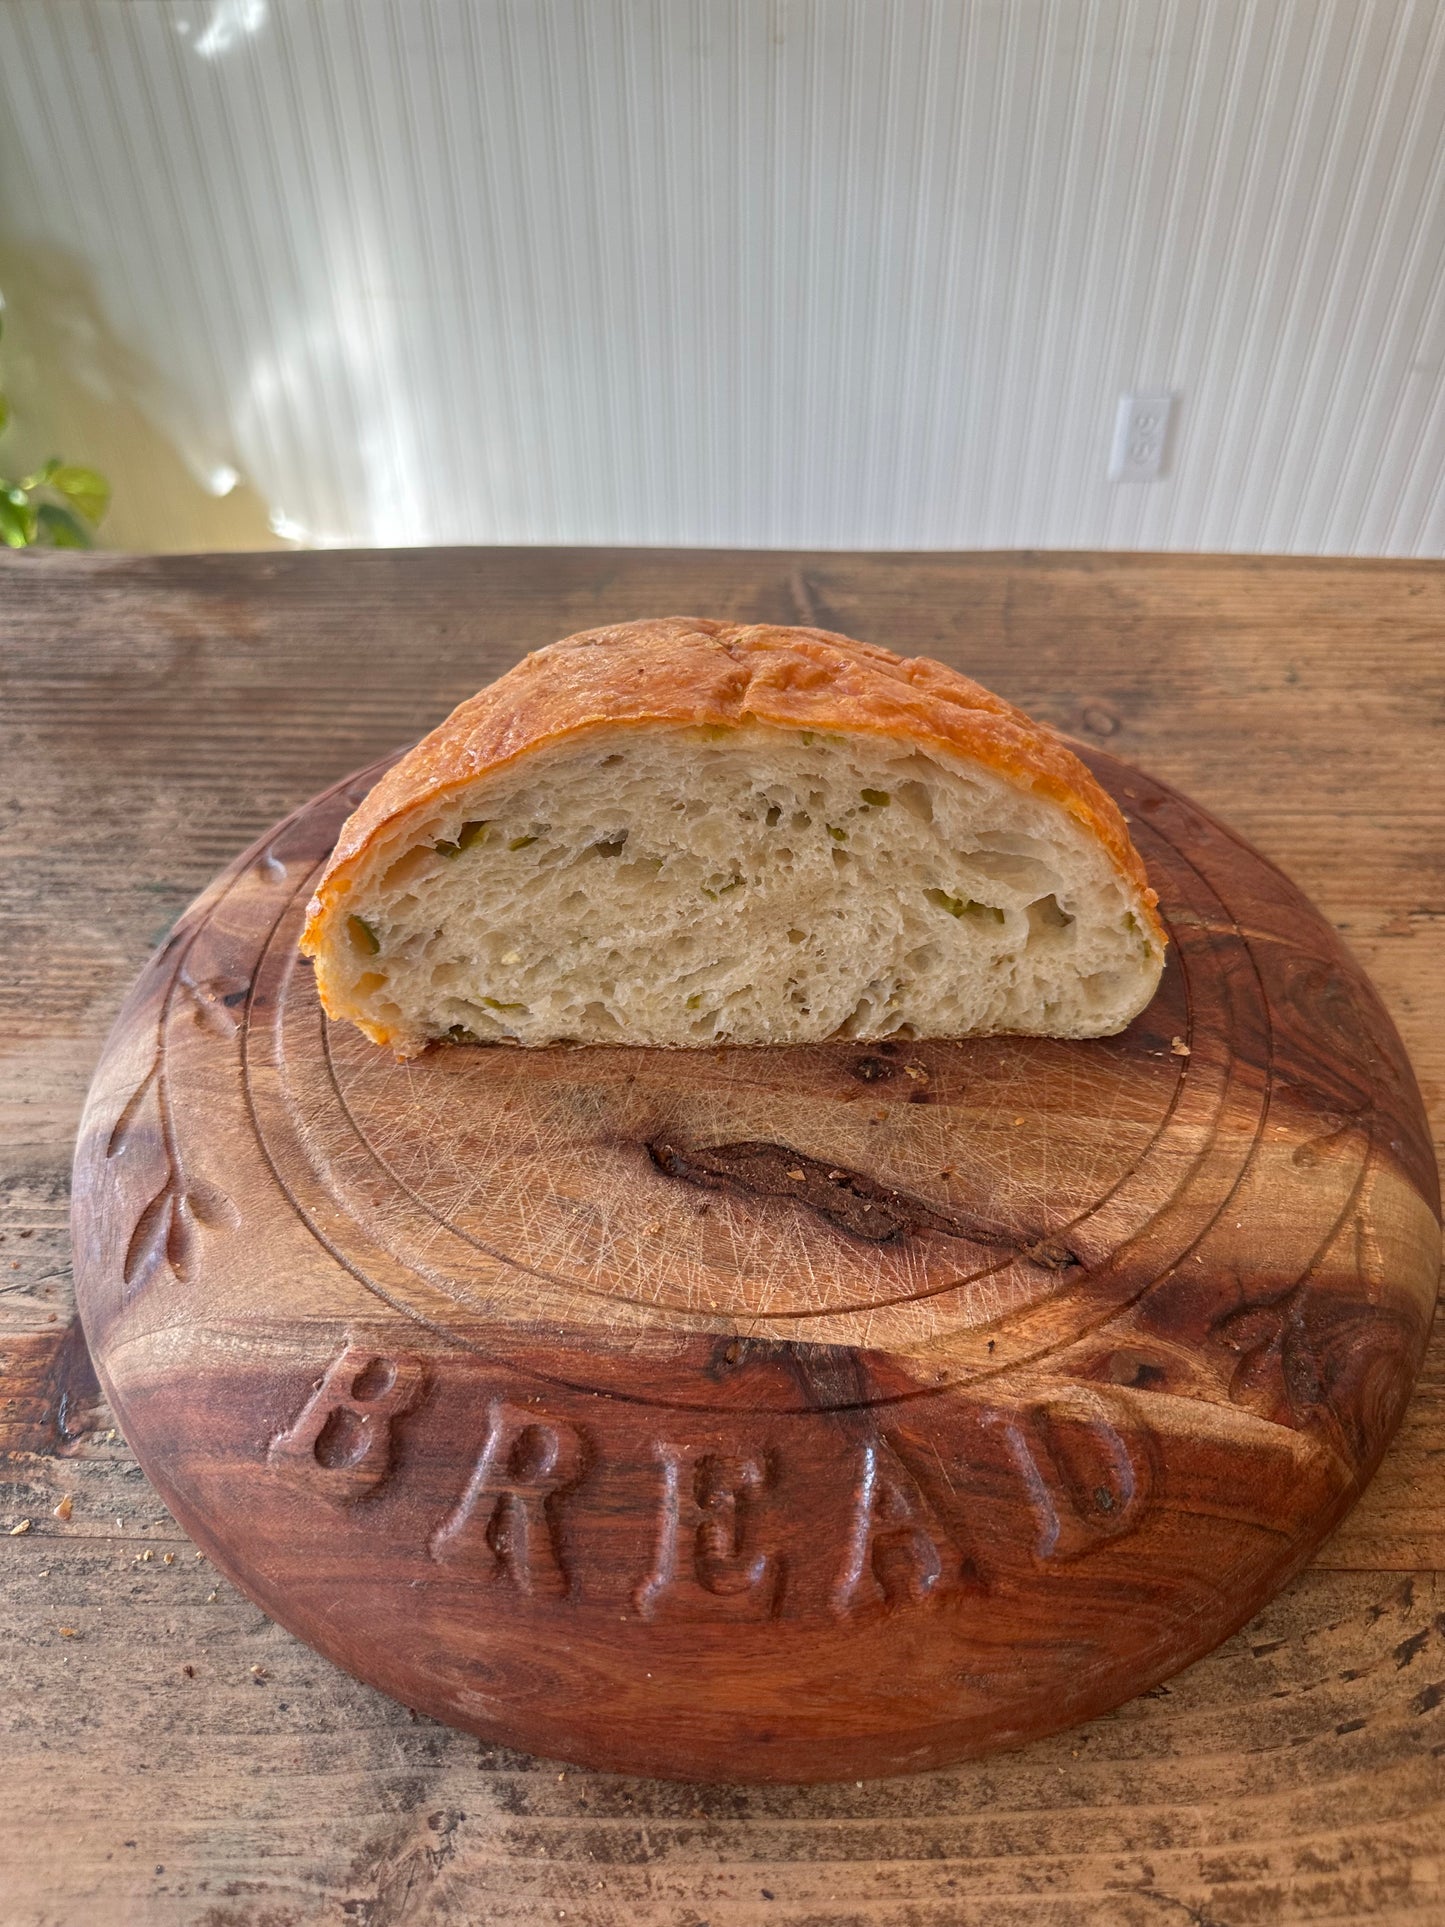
{"left": 302, "top": 617, "right": 1166, "bottom": 956}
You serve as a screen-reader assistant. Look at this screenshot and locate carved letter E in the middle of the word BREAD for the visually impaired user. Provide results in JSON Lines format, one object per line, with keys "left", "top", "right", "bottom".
{"left": 634, "top": 1443, "right": 782, "bottom": 1619}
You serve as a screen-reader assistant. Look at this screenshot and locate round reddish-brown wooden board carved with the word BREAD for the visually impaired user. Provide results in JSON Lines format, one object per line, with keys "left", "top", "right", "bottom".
{"left": 73, "top": 753, "right": 1439, "bottom": 1781}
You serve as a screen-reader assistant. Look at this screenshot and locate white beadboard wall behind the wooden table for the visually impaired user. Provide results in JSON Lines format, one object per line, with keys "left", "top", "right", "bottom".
{"left": 0, "top": 0, "right": 1445, "bottom": 555}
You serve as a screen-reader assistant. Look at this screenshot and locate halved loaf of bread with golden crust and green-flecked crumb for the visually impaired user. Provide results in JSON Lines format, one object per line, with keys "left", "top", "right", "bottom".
{"left": 302, "top": 619, "right": 1166, "bottom": 1058}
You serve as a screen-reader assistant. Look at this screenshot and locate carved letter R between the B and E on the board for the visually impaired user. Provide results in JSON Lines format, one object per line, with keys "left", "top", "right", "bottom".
{"left": 432, "top": 1399, "right": 586, "bottom": 1599}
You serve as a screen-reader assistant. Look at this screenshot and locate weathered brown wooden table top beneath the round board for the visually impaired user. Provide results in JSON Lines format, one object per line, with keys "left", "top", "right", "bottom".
{"left": 0, "top": 549, "right": 1445, "bottom": 1927}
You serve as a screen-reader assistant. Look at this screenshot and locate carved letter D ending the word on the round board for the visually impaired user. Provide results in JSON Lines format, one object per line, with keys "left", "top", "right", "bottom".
{"left": 1006, "top": 1386, "right": 1154, "bottom": 1561}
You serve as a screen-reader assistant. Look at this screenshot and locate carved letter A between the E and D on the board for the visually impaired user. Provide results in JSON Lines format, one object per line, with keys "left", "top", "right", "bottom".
{"left": 832, "top": 1438, "right": 977, "bottom": 1615}
